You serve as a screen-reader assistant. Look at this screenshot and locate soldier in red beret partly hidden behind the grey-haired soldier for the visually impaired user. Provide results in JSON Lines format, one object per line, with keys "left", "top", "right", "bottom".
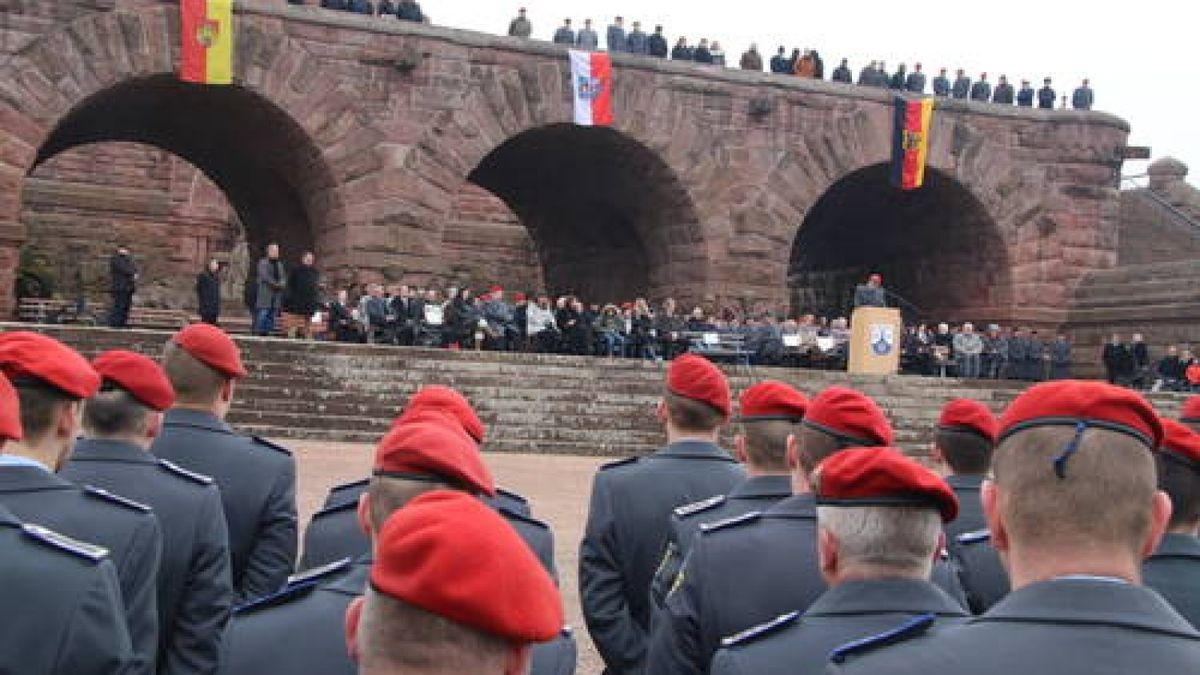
{"left": 646, "top": 387, "right": 961, "bottom": 675}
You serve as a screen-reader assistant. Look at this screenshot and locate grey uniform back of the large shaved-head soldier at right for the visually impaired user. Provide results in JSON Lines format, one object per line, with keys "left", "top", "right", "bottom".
{"left": 829, "top": 578, "right": 1200, "bottom": 675}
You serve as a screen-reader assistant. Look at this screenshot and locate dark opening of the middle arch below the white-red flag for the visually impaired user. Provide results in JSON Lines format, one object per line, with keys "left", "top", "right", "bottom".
{"left": 468, "top": 124, "right": 703, "bottom": 303}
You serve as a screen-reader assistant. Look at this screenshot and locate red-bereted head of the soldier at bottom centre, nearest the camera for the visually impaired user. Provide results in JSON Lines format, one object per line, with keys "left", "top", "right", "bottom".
{"left": 346, "top": 490, "right": 563, "bottom": 675}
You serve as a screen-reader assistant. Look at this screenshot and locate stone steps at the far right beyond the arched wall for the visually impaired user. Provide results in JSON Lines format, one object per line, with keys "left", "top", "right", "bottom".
{"left": 1067, "top": 258, "right": 1200, "bottom": 377}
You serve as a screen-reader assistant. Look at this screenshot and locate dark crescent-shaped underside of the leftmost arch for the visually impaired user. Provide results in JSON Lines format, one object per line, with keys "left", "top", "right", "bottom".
{"left": 30, "top": 74, "right": 336, "bottom": 269}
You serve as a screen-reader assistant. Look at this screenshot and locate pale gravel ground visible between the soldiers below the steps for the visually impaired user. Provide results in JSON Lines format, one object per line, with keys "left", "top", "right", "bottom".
{"left": 286, "top": 441, "right": 608, "bottom": 675}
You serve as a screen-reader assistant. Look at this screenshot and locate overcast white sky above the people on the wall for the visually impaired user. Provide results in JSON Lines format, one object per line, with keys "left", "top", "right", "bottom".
{"left": 421, "top": 0, "right": 1200, "bottom": 185}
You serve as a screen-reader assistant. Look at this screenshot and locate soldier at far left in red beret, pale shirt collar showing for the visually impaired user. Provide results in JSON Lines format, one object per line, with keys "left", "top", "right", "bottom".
{"left": 0, "top": 331, "right": 162, "bottom": 674}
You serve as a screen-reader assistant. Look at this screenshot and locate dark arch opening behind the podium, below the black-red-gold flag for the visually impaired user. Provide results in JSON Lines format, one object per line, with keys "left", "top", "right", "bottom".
{"left": 788, "top": 165, "right": 1012, "bottom": 321}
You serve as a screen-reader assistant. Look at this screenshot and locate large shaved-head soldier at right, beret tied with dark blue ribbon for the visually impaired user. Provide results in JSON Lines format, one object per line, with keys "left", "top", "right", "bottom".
{"left": 828, "top": 380, "right": 1200, "bottom": 675}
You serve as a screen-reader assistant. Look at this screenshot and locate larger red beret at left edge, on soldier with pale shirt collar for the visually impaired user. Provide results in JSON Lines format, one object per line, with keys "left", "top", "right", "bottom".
{"left": 0, "top": 330, "right": 100, "bottom": 399}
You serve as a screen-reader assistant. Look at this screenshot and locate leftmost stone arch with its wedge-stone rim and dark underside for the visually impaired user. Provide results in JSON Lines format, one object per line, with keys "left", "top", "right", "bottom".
{"left": 0, "top": 4, "right": 380, "bottom": 311}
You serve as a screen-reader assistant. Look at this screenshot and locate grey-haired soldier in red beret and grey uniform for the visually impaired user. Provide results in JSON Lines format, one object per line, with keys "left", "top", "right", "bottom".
{"left": 709, "top": 448, "right": 968, "bottom": 675}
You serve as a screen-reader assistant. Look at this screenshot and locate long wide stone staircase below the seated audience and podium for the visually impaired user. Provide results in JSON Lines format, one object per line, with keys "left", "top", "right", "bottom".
{"left": 7, "top": 324, "right": 1182, "bottom": 455}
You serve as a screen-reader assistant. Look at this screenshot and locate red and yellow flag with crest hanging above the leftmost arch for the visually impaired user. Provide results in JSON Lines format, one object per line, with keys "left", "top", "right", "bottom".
{"left": 179, "top": 0, "right": 233, "bottom": 84}
